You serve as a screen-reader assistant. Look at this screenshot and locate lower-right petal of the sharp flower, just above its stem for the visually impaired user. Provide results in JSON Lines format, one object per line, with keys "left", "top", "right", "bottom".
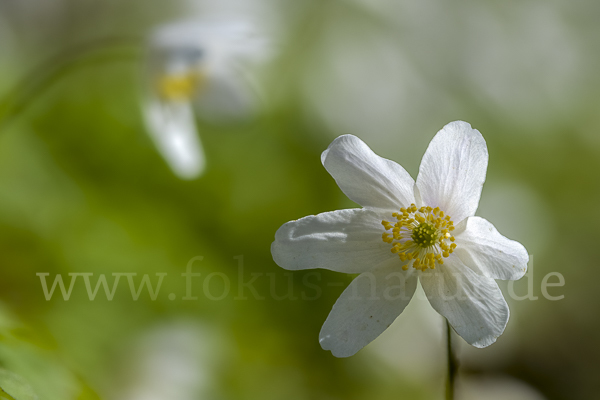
{"left": 419, "top": 256, "right": 510, "bottom": 347}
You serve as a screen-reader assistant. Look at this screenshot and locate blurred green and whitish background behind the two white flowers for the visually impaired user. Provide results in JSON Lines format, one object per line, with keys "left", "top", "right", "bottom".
{"left": 0, "top": 0, "right": 600, "bottom": 400}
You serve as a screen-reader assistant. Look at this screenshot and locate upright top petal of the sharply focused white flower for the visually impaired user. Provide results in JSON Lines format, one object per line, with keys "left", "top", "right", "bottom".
{"left": 417, "top": 121, "right": 488, "bottom": 222}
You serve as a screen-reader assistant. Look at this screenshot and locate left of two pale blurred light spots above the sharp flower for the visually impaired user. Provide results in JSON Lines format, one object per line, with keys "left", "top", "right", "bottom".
{"left": 299, "top": 18, "right": 444, "bottom": 145}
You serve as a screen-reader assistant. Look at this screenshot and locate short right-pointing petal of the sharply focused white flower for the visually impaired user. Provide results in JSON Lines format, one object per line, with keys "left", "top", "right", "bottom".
{"left": 455, "top": 217, "right": 529, "bottom": 280}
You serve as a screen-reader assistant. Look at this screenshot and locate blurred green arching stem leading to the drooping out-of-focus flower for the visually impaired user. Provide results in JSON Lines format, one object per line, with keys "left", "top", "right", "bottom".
{"left": 0, "top": 38, "right": 140, "bottom": 128}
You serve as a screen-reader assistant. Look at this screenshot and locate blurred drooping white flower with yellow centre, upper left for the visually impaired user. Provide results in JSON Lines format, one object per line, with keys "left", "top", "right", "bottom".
{"left": 143, "top": 18, "right": 266, "bottom": 179}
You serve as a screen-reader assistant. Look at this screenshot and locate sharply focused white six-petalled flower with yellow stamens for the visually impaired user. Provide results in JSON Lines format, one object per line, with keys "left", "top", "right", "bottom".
{"left": 271, "top": 121, "right": 529, "bottom": 357}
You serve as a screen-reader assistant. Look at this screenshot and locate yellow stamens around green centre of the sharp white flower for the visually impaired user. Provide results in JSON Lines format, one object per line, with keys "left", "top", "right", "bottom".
{"left": 381, "top": 204, "right": 456, "bottom": 271}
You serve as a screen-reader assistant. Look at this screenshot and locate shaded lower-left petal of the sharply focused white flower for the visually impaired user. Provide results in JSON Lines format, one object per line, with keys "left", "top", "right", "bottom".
{"left": 319, "top": 264, "right": 417, "bottom": 357}
